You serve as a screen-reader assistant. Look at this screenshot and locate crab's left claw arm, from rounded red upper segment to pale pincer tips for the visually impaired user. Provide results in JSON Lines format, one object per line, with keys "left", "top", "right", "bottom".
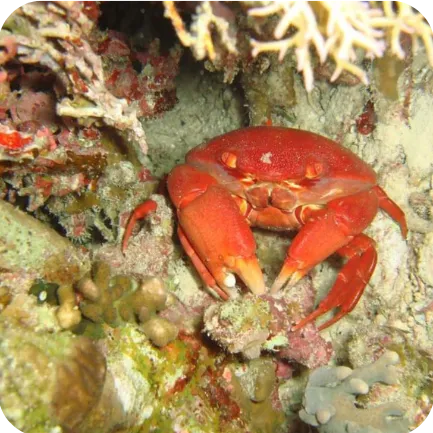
{"left": 168, "top": 165, "right": 265, "bottom": 297}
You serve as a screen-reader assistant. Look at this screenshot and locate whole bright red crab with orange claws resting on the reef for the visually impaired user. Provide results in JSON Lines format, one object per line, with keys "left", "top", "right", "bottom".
{"left": 122, "top": 126, "right": 407, "bottom": 330}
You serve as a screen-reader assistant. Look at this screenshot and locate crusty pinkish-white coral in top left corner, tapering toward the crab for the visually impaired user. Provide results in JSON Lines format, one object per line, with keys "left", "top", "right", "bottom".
{"left": 0, "top": 0, "right": 146, "bottom": 152}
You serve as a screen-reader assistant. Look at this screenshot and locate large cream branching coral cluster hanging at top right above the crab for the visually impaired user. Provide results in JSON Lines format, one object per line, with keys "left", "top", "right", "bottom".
{"left": 248, "top": 0, "right": 433, "bottom": 91}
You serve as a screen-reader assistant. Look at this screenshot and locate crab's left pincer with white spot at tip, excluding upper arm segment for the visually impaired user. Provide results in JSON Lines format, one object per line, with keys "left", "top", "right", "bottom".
{"left": 179, "top": 187, "right": 265, "bottom": 299}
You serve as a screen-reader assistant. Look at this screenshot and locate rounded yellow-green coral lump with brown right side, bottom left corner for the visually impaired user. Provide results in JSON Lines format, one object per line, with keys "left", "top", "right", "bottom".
{"left": 0, "top": 317, "right": 106, "bottom": 433}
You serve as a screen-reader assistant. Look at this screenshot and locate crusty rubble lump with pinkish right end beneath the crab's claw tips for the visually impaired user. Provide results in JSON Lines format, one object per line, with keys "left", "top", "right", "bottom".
{"left": 204, "top": 283, "right": 332, "bottom": 368}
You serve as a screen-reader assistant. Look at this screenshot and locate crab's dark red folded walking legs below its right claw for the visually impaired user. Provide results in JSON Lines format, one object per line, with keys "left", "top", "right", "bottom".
{"left": 292, "top": 234, "right": 377, "bottom": 331}
